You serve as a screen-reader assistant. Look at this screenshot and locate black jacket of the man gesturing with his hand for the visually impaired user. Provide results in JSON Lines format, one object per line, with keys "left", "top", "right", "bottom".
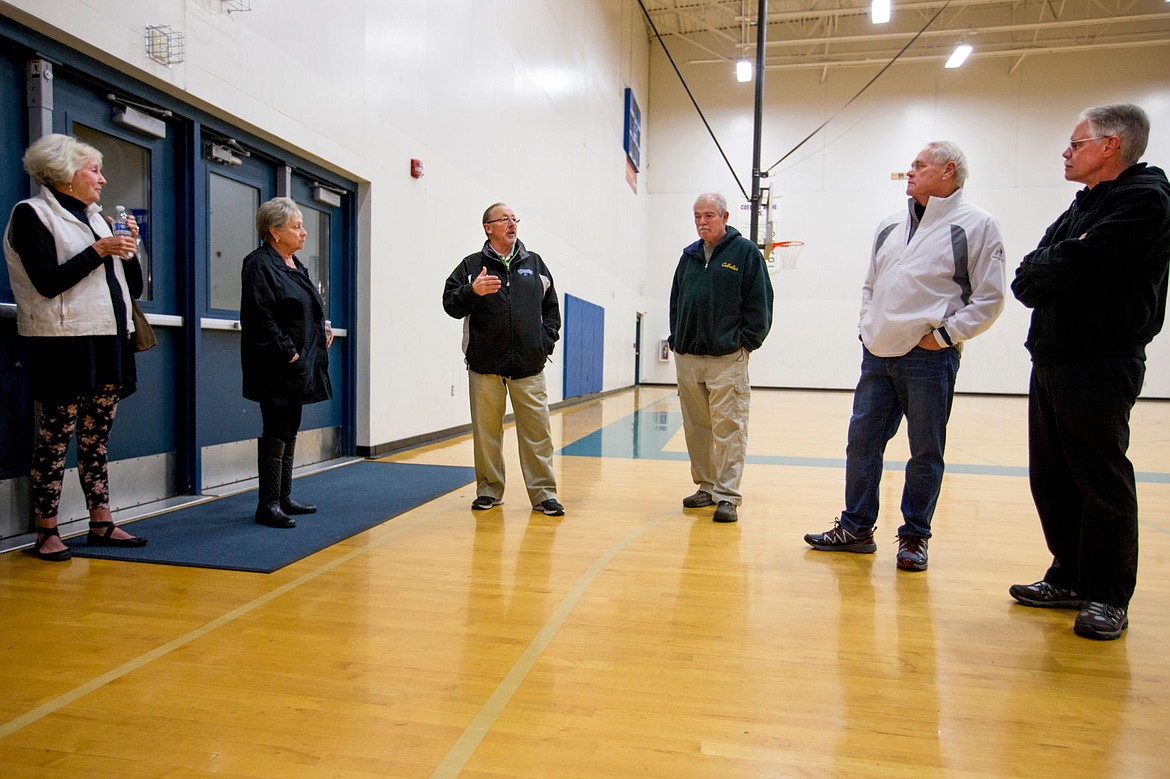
{"left": 442, "top": 241, "right": 560, "bottom": 379}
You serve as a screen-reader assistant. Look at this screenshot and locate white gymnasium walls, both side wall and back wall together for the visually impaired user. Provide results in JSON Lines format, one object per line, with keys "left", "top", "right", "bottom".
{"left": 0, "top": 0, "right": 1170, "bottom": 456}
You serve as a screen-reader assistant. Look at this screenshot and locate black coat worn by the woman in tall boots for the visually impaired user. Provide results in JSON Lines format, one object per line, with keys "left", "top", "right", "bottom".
{"left": 240, "top": 243, "right": 333, "bottom": 405}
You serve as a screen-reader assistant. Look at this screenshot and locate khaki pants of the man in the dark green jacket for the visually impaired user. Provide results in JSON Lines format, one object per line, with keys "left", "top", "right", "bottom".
{"left": 675, "top": 350, "right": 751, "bottom": 505}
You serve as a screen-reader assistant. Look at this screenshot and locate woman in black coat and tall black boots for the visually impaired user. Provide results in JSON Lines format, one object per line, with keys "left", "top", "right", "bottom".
{"left": 240, "top": 198, "right": 333, "bottom": 528}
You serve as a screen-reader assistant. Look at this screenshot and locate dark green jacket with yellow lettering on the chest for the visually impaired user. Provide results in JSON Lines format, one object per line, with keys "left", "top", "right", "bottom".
{"left": 670, "top": 227, "right": 772, "bottom": 356}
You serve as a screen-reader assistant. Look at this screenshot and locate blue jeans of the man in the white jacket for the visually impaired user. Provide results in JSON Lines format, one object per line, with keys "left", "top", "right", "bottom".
{"left": 841, "top": 346, "right": 959, "bottom": 538}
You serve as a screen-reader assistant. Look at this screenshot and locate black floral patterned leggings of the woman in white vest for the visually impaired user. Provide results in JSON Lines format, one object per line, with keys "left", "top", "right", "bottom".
{"left": 29, "top": 385, "right": 118, "bottom": 522}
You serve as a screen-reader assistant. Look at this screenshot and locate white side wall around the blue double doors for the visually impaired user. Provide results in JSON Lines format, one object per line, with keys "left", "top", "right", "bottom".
{"left": 0, "top": 0, "right": 649, "bottom": 446}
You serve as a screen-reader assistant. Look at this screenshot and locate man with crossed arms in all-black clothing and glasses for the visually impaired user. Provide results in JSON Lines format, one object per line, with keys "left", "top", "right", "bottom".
{"left": 1010, "top": 104, "right": 1170, "bottom": 640}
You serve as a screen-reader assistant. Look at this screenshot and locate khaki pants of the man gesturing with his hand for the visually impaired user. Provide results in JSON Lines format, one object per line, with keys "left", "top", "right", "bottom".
{"left": 467, "top": 371, "right": 557, "bottom": 506}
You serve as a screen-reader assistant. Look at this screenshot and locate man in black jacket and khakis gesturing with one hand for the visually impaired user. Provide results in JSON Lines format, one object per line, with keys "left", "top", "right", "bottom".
{"left": 442, "top": 202, "right": 565, "bottom": 517}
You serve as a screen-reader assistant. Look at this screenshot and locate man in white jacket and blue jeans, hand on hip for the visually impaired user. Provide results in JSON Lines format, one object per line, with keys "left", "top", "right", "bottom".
{"left": 805, "top": 142, "right": 1006, "bottom": 571}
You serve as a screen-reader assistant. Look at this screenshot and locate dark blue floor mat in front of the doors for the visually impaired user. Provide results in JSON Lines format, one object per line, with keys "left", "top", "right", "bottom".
{"left": 66, "top": 461, "right": 475, "bottom": 573}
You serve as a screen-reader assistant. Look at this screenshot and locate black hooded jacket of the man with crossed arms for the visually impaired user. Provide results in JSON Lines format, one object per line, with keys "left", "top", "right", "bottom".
{"left": 1012, "top": 163, "right": 1170, "bottom": 365}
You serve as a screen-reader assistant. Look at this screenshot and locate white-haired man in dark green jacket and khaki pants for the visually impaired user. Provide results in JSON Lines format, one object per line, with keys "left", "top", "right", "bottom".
{"left": 670, "top": 193, "right": 772, "bottom": 522}
